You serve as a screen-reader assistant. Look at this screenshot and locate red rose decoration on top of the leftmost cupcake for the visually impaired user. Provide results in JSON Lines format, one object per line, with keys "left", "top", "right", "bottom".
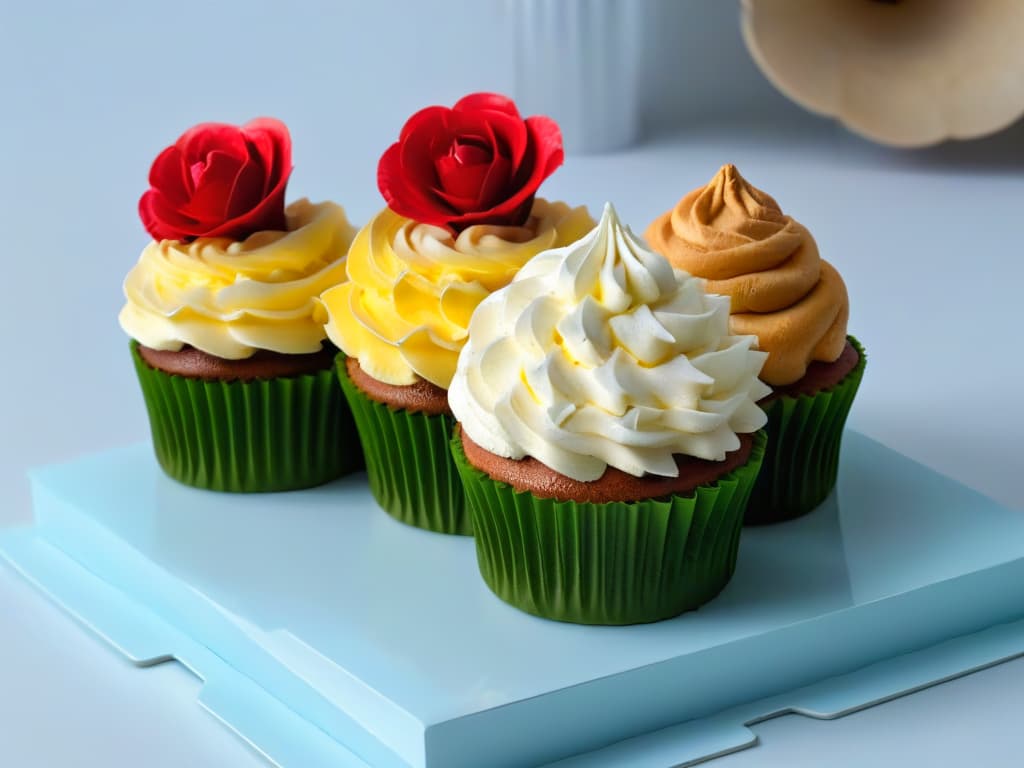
{"left": 138, "top": 118, "right": 292, "bottom": 242}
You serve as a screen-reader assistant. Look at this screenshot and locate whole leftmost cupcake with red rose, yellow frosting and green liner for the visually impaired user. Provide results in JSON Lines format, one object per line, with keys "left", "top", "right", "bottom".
{"left": 119, "top": 118, "right": 361, "bottom": 492}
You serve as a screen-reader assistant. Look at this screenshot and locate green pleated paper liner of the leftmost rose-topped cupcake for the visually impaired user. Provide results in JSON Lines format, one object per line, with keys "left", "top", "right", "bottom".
{"left": 131, "top": 341, "right": 361, "bottom": 493}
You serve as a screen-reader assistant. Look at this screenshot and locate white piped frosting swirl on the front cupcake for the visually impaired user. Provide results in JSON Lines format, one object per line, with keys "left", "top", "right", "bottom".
{"left": 449, "top": 205, "right": 770, "bottom": 481}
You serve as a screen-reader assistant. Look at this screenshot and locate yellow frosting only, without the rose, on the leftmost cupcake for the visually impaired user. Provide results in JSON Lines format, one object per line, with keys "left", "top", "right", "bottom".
{"left": 118, "top": 200, "right": 355, "bottom": 359}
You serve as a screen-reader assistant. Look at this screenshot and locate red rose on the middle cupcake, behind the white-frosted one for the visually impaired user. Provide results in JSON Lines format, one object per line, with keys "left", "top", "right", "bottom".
{"left": 377, "top": 93, "right": 564, "bottom": 232}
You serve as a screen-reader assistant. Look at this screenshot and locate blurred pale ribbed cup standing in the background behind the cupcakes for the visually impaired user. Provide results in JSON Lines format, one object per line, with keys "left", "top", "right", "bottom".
{"left": 506, "top": 0, "right": 646, "bottom": 153}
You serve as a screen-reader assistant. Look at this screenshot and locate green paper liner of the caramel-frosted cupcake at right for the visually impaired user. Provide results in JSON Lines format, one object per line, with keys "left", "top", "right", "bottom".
{"left": 745, "top": 336, "right": 866, "bottom": 525}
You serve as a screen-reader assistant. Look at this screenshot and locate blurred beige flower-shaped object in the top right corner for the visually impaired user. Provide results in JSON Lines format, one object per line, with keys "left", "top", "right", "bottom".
{"left": 742, "top": 0, "right": 1024, "bottom": 146}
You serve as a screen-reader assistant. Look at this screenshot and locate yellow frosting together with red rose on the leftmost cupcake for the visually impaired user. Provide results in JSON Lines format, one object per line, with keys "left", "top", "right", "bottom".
{"left": 119, "top": 118, "right": 355, "bottom": 359}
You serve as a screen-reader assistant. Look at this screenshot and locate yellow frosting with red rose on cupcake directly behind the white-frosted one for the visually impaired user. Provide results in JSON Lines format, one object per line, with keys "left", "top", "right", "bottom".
{"left": 321, "top": 93, "right": 593, "bottom": 389}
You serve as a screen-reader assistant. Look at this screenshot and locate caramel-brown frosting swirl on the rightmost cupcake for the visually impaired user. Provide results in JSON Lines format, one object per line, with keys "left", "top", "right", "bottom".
{"left": 645, "top": 165, "right": 850, "bottom": 386}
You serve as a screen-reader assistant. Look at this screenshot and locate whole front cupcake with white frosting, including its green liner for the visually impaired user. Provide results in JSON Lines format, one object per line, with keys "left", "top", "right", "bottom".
{"left": 449, "top": 206, "right": 769, "bottom": 625}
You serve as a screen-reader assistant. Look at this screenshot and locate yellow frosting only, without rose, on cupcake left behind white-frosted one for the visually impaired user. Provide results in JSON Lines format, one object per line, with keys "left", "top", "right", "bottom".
{"left": 321, "top": 198, "right": 594, "bottom": 389}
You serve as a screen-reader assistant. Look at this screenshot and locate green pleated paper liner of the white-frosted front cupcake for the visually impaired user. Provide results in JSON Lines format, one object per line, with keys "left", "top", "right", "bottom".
{"left": 452, "top": 432, "right": 765, "bottom": 625}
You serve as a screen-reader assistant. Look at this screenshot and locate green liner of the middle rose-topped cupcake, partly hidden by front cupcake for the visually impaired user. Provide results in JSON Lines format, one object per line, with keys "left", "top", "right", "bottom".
{"left": 337, "top": 355, "right": 473, "bottom": 536}
